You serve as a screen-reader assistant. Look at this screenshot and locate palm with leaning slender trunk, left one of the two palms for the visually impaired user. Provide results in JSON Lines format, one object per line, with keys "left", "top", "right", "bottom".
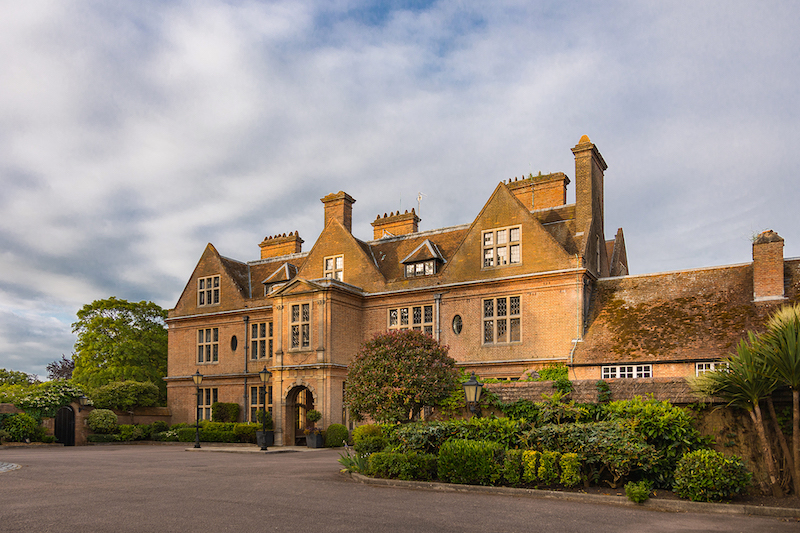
{"left": 692, "top": 332, "right": 783, "bottom": 497}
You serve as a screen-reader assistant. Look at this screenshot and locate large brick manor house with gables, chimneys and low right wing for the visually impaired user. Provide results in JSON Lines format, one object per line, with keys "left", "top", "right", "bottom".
{"left": 166, "top": 135, "right": 800, "bottom": 445}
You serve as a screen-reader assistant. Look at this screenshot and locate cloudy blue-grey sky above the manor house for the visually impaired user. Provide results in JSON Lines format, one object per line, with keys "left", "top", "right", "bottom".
{"left": 0, "top": 0, "right": 800, "bottom": 376}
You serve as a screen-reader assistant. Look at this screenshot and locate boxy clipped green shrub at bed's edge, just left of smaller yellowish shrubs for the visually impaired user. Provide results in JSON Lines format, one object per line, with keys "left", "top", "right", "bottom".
{"left": 438, "top": 439, "right": 505, "bottom": 485}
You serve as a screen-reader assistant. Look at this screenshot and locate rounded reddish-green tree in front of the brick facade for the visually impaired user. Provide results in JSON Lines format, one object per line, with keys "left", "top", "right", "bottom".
{"left": 345, "top": 331, "right": 458, "bottom": 422}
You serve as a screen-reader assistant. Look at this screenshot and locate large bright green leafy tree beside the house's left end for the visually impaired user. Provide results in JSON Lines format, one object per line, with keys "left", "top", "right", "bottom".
{"left": 72, "top": 296, "right": 167, "bottom": 397}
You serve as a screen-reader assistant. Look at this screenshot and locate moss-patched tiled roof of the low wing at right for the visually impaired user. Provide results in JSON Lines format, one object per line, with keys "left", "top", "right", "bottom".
{"left": 574, "top": 259, "right": 800, "bottom": 365}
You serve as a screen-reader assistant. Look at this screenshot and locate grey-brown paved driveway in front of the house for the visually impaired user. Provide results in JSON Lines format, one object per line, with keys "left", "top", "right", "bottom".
{"left": 0, "top": 446, "right": 800, "bottom": 533}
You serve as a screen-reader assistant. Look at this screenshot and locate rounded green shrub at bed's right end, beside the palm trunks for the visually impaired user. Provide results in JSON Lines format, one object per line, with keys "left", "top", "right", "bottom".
{"left": 674, "top": 450, "right": 752, "bottom": 502}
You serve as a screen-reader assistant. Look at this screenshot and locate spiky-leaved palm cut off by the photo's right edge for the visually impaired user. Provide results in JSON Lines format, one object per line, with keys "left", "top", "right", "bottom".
{"left": 761, "top": 305, "right": 800, "bottom": 494}
